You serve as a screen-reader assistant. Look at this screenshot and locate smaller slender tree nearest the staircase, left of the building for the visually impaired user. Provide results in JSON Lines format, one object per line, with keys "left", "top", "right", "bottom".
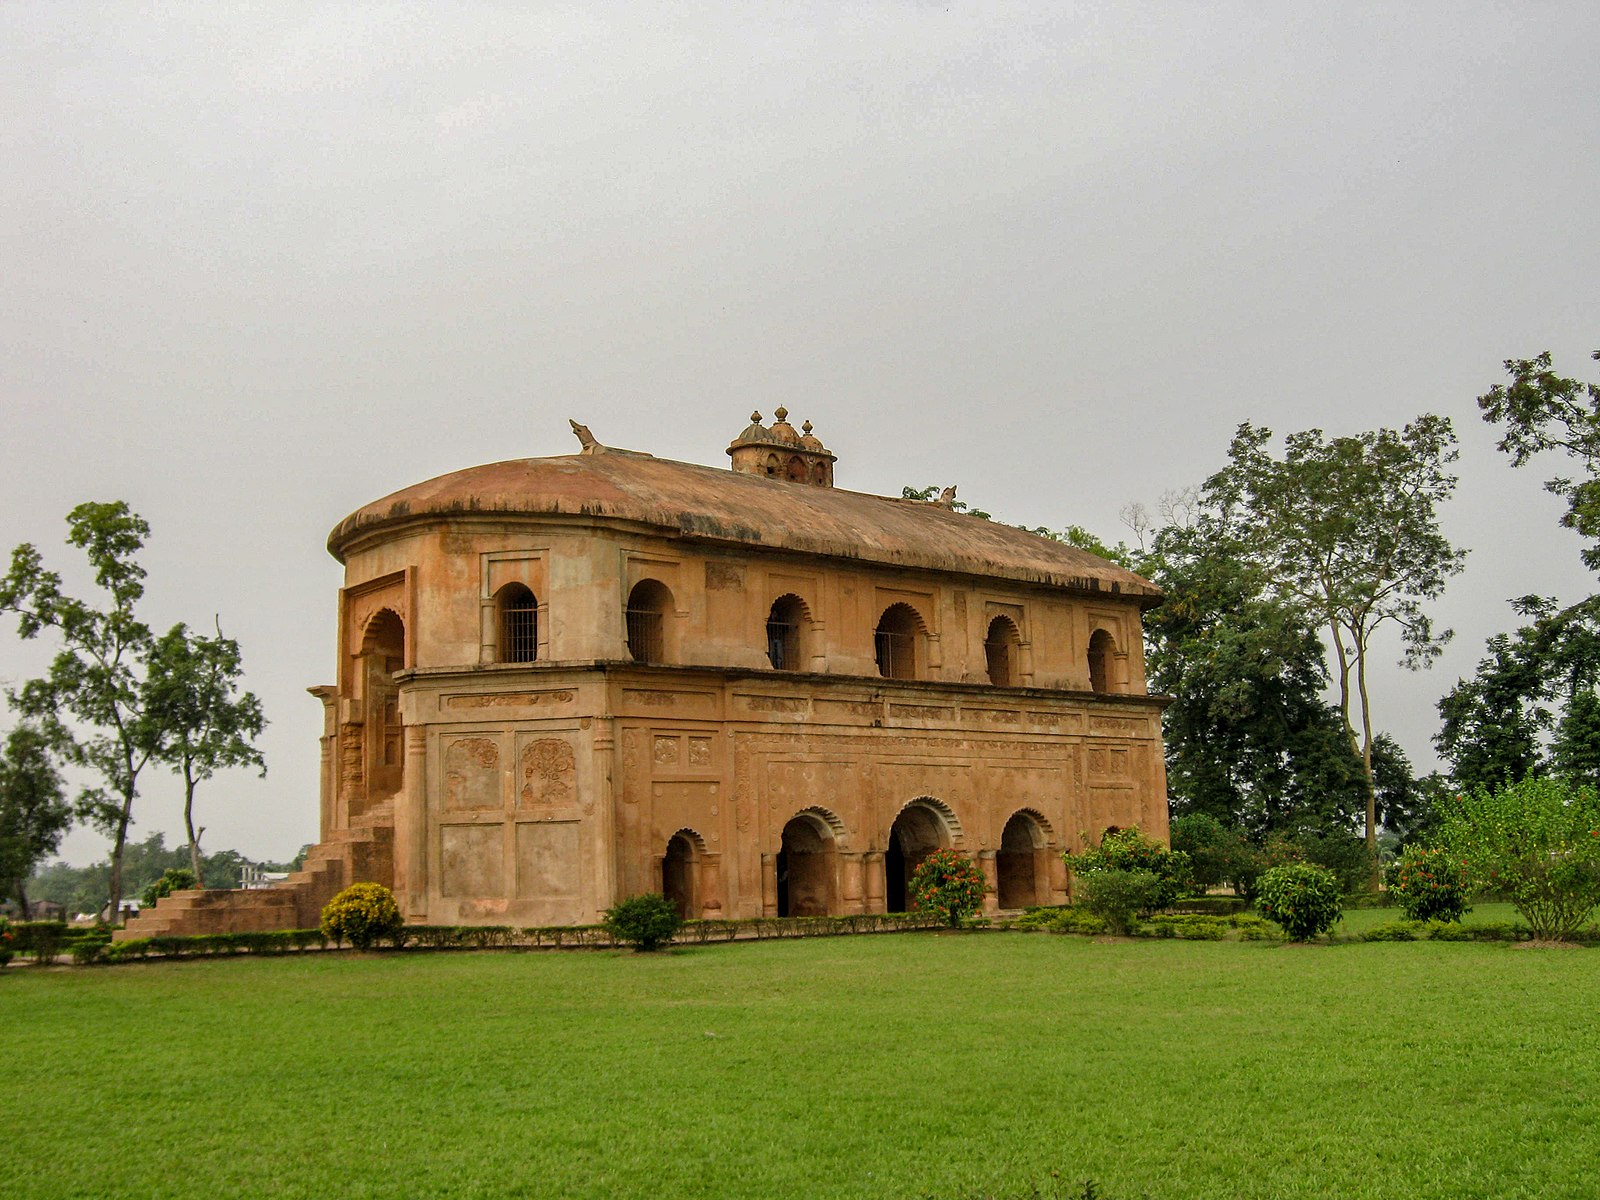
{"left": 147, "top": 624, "right": 267, "bottom": 888}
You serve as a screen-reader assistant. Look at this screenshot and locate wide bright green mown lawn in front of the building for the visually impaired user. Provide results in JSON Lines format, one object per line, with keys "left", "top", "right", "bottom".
{"left": 0, "top": 933, "right": 1600, "bottom": 1200}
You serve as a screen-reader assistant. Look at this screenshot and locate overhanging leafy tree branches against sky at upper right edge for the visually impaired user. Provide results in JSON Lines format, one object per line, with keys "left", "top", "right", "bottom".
{"left": 1478, "top": 350, "right": 1600, "bottom": 571}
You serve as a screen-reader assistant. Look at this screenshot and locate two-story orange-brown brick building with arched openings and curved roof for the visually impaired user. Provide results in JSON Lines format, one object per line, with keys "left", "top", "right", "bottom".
{"left": 121, "top": 410, "right": 1166, "bottom": 931}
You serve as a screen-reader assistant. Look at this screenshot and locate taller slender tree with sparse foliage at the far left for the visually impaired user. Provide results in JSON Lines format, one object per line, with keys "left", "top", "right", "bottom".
{"left": 0, "top": 501, "right": 165, "bottom": 920}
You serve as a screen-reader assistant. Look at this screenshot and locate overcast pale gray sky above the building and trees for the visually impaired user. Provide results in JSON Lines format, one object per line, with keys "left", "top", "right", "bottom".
{"left": 0, "top": 0, "right": 1600, "bottom": 862}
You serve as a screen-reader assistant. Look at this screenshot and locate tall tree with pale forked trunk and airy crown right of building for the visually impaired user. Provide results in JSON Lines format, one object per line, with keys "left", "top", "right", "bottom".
{"left": 1203, "top": 414, "right": 1466, "bottom": 864}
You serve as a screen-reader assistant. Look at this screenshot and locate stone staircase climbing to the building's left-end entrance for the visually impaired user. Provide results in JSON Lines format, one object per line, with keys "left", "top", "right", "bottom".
{"left": 112, "top": 798, "right": 395, "bottom": 941}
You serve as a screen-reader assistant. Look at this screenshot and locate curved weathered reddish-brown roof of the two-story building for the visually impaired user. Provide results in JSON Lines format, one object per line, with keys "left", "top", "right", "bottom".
{"left": 328, "top": 450, "right": 1160, "bottom": 605}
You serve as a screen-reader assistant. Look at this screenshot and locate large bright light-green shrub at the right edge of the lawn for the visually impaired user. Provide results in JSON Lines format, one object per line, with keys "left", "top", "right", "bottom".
{"left": 1435, "top": 778, "right": 1600, "bottom": 941}
